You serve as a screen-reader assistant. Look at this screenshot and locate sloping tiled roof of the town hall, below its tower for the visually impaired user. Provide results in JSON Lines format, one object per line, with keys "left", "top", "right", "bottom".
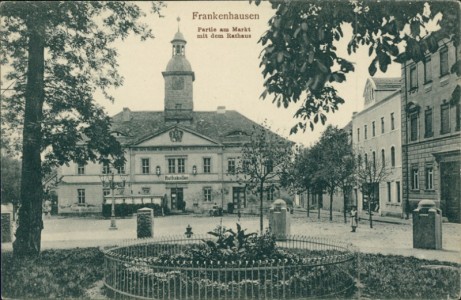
{"left": 112, "top": 110, "right": 287, "bottom": 145}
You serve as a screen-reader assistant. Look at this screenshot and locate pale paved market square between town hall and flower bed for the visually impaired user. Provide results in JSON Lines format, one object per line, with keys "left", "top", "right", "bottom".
{"left": 2, "top": 212, "right": 461, "bottom": 262}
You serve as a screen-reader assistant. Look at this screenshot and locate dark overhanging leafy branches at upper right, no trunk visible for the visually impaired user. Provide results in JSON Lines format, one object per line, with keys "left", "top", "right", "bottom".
{"left": 256, "top": 0, "right": 461, "bottom": 132}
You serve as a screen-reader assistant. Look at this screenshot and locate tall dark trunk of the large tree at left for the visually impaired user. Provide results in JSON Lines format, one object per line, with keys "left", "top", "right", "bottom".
{"left": 13, "top": 24, "right": 45, "bottom": 256}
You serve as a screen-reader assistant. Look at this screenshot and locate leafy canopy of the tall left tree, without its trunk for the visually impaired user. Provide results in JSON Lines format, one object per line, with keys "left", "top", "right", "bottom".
{"left": 0, "top": 1, "right": 162, "bottom": 170}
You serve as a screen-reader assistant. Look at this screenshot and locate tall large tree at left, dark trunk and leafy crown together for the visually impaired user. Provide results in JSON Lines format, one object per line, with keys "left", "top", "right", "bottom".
{"left": 0, "top": 1, "right": 164, "bottom": 256}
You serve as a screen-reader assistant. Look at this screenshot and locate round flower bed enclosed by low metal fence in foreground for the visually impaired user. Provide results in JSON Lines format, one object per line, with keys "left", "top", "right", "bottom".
{"left": 105, "top": 224, "right": 358, "bottom": 299}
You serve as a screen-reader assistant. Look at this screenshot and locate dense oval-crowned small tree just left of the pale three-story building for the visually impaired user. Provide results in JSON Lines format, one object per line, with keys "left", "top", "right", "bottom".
{"left": 317, "top": 125, "right": 354, "bottom": 221}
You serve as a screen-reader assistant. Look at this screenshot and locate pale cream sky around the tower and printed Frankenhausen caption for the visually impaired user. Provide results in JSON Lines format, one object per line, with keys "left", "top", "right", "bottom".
{"left": 2, "top": 0, "right": 400, "bottom": 145}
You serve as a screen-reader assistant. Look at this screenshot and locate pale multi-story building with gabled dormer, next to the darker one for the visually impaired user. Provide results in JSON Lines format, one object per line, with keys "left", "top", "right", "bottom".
{"left": 352, "top": 78, "right": 403, "bottom": 216}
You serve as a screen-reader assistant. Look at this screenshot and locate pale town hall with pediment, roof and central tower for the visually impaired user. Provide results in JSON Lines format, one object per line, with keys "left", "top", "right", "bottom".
{"left": 57, "top": 31, "right": 288, "bottom": 213}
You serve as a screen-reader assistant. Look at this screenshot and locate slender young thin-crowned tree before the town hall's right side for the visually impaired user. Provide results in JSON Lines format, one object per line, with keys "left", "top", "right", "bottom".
{"left": 236, "top": 126, "right": 293, "bottom": 233}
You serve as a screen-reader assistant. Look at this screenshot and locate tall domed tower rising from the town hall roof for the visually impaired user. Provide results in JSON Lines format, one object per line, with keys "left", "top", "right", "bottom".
{"left": 162, "top": 19, "right": 195, "bottom": 122}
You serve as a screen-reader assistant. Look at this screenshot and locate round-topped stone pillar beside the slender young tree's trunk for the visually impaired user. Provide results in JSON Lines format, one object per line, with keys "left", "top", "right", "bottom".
{"left": 269, "top": 199, "right": 291, "bottom": 241}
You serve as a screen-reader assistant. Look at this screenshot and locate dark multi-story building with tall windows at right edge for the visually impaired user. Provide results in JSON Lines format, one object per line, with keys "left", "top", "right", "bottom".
{"left": 401, "top": 39, "right": 461, "bottom": 223}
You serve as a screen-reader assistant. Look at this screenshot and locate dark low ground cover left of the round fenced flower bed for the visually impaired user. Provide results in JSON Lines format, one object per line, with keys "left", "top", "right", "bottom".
{"left": 1, "top": 248, "right": 104, "bottom": 299}
